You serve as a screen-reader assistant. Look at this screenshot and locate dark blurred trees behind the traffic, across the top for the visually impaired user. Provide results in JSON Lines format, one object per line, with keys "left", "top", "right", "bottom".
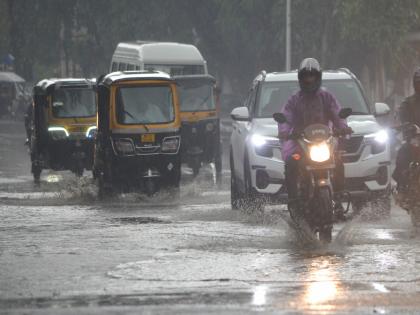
{"left": 0, "top": 0, "right": 420, "bottom": 92}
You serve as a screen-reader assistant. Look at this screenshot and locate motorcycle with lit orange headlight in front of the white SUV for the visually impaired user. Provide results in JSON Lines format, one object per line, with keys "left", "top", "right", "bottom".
{"left": 273, "top": 108, "right": 352, "bottom": 243}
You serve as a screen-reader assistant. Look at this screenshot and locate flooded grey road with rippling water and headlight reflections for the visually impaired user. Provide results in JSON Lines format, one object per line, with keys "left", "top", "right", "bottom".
{"left": 0, "top": 122, "right": 420, "bottom": 314}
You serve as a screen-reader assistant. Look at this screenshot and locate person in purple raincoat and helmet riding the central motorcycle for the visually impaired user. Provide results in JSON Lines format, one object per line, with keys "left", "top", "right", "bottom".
{"left": 279, "top": 58, "right": 351, "bottom": 219}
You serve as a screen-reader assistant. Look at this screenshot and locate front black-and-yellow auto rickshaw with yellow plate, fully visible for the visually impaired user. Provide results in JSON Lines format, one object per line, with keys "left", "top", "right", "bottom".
{"left": 94, "top": 71, "right": 181, "bottom": 196}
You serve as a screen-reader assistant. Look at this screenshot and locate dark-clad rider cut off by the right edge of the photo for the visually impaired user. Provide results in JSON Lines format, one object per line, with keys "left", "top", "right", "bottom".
{"left": 392, "top": 68, "right": 420, "bottom": 201}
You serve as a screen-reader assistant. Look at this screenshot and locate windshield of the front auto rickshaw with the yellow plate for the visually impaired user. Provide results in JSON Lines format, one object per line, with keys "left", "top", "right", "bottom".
{"left": 116, "top": 85, "right": 175, "bottom": 124}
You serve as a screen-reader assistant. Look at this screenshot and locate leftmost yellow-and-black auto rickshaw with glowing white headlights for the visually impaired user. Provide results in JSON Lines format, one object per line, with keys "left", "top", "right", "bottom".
{"left": 29, "top": 79, "right": 96, "bottom": 182}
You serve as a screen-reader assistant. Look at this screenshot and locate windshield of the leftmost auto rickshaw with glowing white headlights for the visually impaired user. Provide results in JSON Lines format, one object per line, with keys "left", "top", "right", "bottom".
{"left": 52, "top": 87, "right": 96, "bottom": 118}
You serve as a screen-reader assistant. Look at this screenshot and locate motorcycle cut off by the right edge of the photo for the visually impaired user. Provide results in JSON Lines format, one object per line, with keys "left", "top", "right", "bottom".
{"left": 392, "top": 123, "right": 420, "bottom": 227}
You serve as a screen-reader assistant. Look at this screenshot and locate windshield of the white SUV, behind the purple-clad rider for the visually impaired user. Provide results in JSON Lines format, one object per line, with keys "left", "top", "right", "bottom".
{"left": 255, "top": 80, "right": 369, "bottom": 118}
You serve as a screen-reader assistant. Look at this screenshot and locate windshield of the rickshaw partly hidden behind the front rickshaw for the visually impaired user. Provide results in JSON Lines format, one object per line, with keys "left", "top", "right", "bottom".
{"left": 178, "top": 82, "right": 216, "bottom": 112}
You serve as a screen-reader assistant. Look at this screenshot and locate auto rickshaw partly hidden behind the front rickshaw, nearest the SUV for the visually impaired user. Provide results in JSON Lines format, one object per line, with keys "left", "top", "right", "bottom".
{"left": 174, "top": 75, "right": 222, "bottom": 181}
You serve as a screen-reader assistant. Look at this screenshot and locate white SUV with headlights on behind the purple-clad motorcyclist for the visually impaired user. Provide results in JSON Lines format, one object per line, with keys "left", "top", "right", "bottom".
{"left": 230, "top": 69, "right": 391, "bottom": 212}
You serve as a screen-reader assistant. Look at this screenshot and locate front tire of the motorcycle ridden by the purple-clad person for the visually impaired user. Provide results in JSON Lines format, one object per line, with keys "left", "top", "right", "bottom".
{"left": 318, "top": 187, "right": 333, "bottom": 243}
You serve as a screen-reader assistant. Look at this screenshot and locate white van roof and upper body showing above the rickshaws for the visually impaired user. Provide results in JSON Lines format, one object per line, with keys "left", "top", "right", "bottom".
{"left": 110, "top": 41, "right": 208, "bottom": 76}
